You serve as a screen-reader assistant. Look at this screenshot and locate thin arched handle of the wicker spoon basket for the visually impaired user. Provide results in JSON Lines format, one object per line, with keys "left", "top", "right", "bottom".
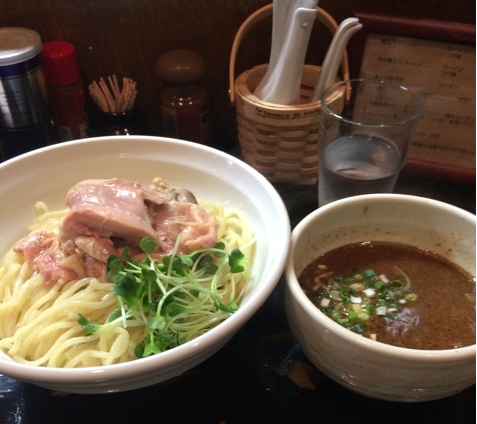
{"left": 229, "top": 3, "right": 349, "bottom": 104}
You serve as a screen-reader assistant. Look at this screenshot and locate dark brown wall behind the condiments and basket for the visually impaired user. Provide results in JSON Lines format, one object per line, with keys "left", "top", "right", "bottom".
{"left": 0, "top": 0, "right": 475, "bottom": 147}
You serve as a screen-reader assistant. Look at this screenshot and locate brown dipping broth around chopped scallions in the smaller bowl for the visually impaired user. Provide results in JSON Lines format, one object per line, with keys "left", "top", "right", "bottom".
{"left": 299, "top": 241, "right": 476, "bottom": 350}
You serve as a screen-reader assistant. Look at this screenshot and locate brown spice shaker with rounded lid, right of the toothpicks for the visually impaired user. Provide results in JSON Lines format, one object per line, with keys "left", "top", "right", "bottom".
{"left": 156, "top": 49, "right": 210, "bottom": 144}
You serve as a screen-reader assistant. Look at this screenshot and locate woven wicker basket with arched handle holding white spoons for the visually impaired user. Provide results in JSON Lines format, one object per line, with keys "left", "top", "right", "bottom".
{"left": 229, "top": 4, "right": 349, "bottom": 185}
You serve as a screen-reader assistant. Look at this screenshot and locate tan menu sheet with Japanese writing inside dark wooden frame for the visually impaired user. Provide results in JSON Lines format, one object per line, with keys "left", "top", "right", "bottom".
{"left": 348, "top": 12, "right": 476, "bottom": 180}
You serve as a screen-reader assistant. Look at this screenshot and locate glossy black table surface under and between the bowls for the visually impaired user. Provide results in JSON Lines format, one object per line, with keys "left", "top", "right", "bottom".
{"left": 0, "top": 149, "right": 476, "bottom": 424}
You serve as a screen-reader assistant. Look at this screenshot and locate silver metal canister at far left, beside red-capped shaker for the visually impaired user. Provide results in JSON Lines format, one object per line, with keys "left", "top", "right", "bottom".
{"left": 0, "top": 27, "right": 54, "bottom": 159}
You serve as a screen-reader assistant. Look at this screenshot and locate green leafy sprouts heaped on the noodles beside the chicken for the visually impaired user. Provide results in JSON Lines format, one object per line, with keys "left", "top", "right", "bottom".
{"left": 78, "top": 237, "right": 250, "bottom": 357}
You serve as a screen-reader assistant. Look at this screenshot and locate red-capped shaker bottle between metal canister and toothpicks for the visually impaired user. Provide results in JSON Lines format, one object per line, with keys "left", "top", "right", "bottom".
{"left": 41, "top": 41, "right": 88, "bottom": 141}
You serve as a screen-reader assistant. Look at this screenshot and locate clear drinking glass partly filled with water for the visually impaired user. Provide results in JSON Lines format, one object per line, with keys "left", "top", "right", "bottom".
{"left": 318, "top": 79, "right": 421, "bottom": 206}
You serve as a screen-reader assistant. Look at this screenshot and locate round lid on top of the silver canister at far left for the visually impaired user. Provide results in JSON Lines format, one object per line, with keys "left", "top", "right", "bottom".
{"left": 0, "top": 27, "right": 42, "bottom": 66}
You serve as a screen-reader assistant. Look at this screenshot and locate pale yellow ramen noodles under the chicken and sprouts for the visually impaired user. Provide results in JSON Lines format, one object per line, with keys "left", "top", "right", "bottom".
{"left": 0, "top": 202, "right": 254, "bottom": 367}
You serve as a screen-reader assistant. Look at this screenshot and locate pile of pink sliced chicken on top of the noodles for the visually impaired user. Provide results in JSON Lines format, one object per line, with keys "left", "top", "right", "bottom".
{"left": 14, "top": 178, "right": 217, "bottom": 285}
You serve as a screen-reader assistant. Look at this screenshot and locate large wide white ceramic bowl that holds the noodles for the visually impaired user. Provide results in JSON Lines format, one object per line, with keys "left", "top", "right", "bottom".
{"left": 0, "top": 136, "right": 290, "bottom": 393}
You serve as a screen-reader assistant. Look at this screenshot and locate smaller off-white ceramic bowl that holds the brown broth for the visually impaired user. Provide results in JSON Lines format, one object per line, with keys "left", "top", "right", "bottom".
{"left": 285, "top": 194, "right": 476, "bottom": 402}
